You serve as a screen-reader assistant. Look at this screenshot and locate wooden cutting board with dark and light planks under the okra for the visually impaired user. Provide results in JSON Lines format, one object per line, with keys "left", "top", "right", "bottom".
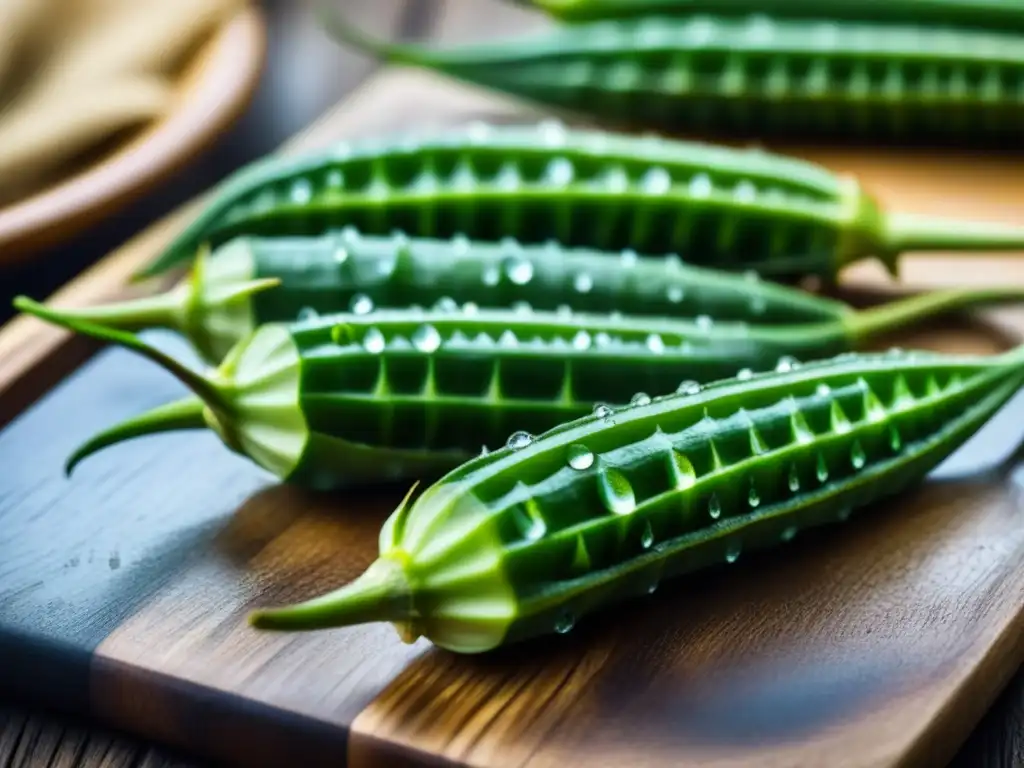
{"left": 8, "top": 51, "right": 1024, "bottom": 768}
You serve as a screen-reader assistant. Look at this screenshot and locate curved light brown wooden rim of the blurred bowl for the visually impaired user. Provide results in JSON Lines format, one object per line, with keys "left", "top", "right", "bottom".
{"left": 0, "top": 5, "right": 266, "bottom": 267}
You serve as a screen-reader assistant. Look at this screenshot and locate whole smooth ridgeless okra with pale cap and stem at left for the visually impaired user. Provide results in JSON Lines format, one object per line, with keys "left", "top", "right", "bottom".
{"left": 58, "top": 227, "right": 853, "bottom": 362}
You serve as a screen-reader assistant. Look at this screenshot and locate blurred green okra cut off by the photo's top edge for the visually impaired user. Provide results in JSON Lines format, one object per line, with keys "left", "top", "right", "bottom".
{"left": 515, "top": 0, "right": 1024, "bottom": 31}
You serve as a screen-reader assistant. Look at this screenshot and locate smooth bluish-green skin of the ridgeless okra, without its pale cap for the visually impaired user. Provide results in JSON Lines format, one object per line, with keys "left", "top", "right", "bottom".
{"left": 246, "top": 228, "right": 853, "bottom": 325}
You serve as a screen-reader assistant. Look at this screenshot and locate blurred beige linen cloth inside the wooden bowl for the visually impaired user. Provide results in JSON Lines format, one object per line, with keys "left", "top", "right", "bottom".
{"left": 0, "top": 0, "right": 247, "bottom": 206}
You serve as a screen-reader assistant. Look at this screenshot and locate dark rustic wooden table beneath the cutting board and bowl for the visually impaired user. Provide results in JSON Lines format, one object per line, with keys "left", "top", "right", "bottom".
{"left": 6, "top": 0, "right": 1024, "bottom": 768}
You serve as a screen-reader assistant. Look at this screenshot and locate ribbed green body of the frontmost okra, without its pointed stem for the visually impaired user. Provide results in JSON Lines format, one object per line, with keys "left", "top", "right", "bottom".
{"left": 372, "top": 350, "right": 1024, "bottom": 651}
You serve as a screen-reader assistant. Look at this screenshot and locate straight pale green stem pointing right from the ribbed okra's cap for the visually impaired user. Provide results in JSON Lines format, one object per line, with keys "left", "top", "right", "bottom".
{"left": 886, "top": 212, "right": 1024, "bottom": 259}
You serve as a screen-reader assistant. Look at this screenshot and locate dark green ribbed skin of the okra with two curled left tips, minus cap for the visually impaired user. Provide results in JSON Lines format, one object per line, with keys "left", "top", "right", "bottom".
{"left": 278, "top": 309, "right": 880, "bottom": 488}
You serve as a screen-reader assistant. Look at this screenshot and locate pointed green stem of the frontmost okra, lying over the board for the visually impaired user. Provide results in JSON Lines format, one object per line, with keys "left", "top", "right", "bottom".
{"left": 249, "top": 556, "right": 413, "bottom": 632}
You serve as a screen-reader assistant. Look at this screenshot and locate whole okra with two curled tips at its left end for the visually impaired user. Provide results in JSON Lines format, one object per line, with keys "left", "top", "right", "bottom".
{"left": 15, "top": 289, "right": 1024, "bottom": 489}
